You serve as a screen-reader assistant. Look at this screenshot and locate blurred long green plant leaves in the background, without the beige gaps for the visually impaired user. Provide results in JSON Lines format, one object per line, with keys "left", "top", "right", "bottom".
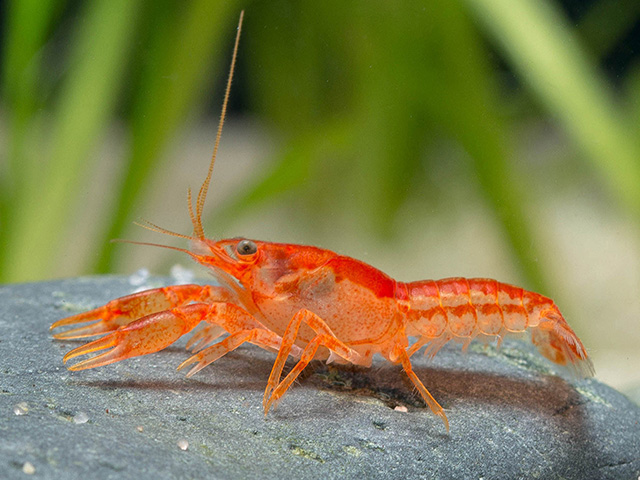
{"left": 0, "top": 0, "right": 640, "bottom": 292}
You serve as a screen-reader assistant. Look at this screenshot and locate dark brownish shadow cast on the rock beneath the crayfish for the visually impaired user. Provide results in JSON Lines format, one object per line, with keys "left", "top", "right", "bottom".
{"left": 74, "top": 347, "right": 586, "bottom": 429}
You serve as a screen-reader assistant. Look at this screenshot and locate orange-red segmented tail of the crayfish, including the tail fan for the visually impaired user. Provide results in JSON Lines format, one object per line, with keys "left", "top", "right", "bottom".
{"left": 399, "top": 277, "right": 594, "bottom": 378}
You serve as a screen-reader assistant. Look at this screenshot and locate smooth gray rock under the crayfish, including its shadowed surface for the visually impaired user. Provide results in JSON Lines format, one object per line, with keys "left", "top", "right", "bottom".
{"left": 0, "top": 277, "right": 640, "bottom": 480}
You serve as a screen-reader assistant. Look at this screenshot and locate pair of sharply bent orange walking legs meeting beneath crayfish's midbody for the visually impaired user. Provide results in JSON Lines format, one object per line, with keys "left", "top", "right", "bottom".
{"left": 262, "top": 310, "right": 361, "bottom": 415}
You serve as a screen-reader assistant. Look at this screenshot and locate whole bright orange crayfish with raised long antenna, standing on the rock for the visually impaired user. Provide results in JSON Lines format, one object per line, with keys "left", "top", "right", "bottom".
{"left": 51, "top": 14, "right": 593, "bottom": 430}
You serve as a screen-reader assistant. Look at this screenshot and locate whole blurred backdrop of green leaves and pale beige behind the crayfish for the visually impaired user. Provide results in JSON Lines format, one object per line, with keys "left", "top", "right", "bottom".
{"left": 0, "top": 0, "right": 640, "bottom": 396}
